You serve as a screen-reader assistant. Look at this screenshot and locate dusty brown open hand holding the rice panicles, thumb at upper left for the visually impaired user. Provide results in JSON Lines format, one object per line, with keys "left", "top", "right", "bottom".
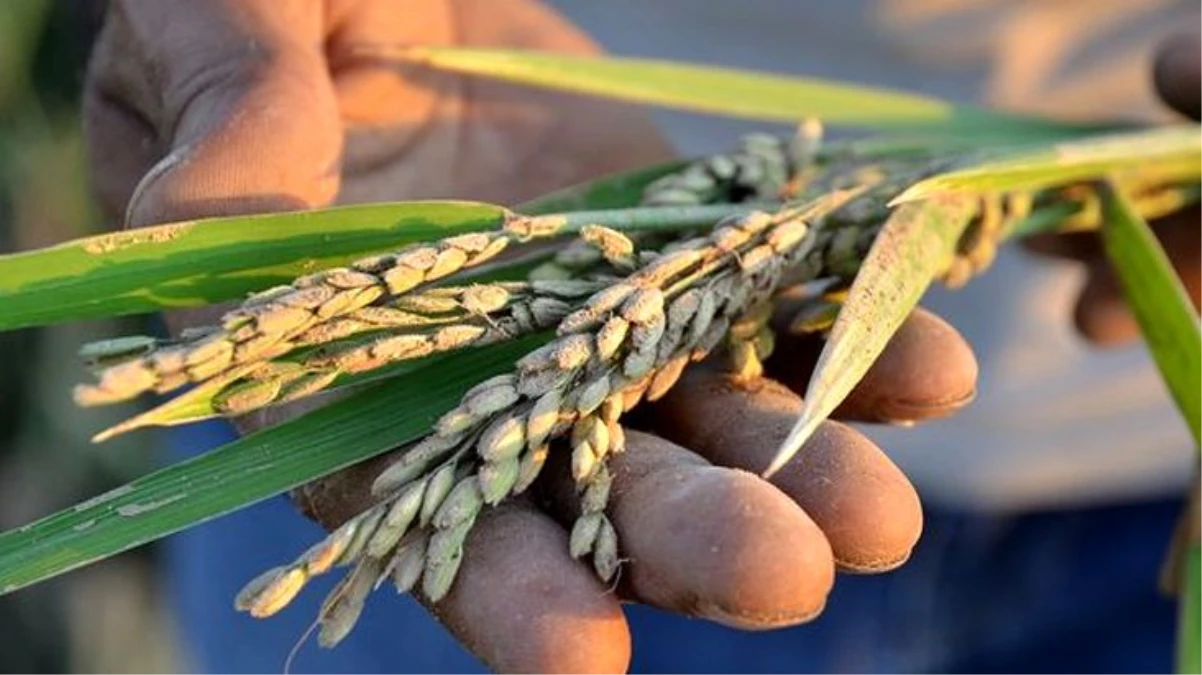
{"left": 85, "top": 0, "right": 1200, "bottom": 674}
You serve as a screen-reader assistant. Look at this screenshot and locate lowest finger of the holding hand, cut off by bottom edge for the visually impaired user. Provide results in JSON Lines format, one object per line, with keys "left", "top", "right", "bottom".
{"left": 294, "top": 456, "right": 630, "bottom": 675}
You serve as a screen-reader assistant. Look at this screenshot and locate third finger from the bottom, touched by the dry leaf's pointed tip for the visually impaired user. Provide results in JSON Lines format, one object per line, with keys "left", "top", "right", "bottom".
{"left": 653, "top": 369, "right": 922, "bottom": 572}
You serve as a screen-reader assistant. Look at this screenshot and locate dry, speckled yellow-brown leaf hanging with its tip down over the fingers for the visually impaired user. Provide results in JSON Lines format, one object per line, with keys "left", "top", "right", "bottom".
{"left": 764, "top": 197, "right": 976, "bottom": 476}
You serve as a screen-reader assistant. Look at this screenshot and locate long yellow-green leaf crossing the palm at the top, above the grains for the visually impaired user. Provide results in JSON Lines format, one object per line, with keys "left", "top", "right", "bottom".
{"left": 396, "top": 47, "right": 1101, "bottom": 139}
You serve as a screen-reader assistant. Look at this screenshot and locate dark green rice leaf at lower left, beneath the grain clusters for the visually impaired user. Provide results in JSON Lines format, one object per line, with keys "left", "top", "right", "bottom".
{"left": 0, "top": 335, "right": 546, "bottom": 595}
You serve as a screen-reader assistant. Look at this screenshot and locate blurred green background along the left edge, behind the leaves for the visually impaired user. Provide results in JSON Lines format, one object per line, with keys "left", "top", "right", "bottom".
{"left": 0, "top": 0, "right": 177, "bottom": 675}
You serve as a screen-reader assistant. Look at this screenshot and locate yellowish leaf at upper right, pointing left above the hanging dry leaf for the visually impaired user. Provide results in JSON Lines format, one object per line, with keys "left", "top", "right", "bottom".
{"left": 893, "top": 125, "right": 1202, "bottom": 204}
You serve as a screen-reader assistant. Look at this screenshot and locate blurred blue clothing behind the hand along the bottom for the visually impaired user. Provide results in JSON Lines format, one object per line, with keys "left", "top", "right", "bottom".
{"left": 166, "top": 423, "right": 1180, "bottom": 675}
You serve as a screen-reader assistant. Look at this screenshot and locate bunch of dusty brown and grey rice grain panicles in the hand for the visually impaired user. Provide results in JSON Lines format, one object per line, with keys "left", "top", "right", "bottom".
{"left": 65, "top": 124, "right": 1196, "bottom": 645}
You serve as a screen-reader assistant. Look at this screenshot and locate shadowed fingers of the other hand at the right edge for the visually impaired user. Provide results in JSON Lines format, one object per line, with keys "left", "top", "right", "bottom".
{"left": 1028, "top": 36, "right": 1202, "bottom": 346}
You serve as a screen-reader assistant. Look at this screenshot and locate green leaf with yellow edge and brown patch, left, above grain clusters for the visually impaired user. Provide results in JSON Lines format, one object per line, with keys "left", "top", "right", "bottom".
{"left": 0, "top": 202, "right": 505, "bottom": 330}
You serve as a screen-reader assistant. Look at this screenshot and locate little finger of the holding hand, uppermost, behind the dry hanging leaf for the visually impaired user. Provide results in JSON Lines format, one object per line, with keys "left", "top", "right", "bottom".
{"left": 769, "top": 304, "right": 977, "bottom": 420}
